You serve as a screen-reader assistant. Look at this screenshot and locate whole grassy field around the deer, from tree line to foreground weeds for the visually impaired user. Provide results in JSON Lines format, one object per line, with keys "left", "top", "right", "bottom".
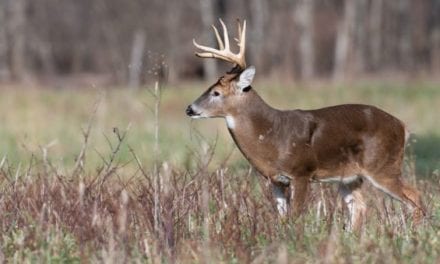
{"left": 0, "top": 82, "right": 440, "bottom": 263}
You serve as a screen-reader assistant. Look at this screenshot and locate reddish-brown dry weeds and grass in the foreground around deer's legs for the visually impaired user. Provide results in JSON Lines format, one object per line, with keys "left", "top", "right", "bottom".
{"left": 0, "top": 133, "right": 440, "bottom": 263}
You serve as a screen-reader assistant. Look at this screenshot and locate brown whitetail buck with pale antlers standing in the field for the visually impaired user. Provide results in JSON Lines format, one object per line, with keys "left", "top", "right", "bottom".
{"left": 186, "top": 20, "right": 424, "bottom": 229}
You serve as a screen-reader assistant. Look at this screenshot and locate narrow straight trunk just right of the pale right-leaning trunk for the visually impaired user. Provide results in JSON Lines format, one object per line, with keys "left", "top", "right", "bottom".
{"left": 369, "top": 0, "right": 384, "bottom": 70}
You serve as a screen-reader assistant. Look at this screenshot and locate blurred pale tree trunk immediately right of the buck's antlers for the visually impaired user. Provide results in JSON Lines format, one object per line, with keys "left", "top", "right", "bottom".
{"left": 249, "top": 0, "right": 267, "bottom": 71}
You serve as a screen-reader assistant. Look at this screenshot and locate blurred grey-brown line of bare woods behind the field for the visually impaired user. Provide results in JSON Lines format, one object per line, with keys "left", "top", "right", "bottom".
{"left": 0, "top": 0, "right": 440, "bottom": 86}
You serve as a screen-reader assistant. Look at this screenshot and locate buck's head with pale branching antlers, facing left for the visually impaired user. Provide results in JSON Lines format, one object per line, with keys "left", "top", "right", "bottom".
{"left": 186, "top": 20, "right": 255, "bottom": 118}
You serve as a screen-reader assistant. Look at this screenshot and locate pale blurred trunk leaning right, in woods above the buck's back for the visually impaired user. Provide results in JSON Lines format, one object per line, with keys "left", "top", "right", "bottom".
{"left": 333, "top": 0, "right": 356, "bottom": 80}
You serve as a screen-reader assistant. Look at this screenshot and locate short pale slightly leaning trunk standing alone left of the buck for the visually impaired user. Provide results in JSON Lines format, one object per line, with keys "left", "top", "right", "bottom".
{"left": 128, "top": 29, "right": 145, "bottom": 89}
